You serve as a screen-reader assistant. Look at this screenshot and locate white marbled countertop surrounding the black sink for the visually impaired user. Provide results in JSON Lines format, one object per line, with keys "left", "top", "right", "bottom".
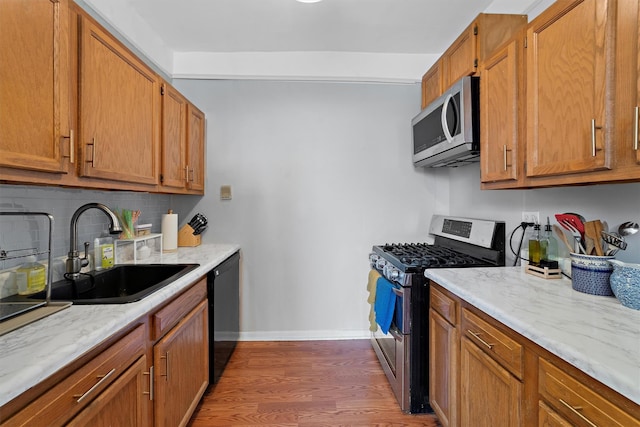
{"left": 0, "top": 244, "right": 240, "bottom": 406}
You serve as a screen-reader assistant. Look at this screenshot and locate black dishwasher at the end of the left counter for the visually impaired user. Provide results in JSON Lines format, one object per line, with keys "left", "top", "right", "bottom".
{"left": 207, "top": 252, "right": 240, "bottom": 384}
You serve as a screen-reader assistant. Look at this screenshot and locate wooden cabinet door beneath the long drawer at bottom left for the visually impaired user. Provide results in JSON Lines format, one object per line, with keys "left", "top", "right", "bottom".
{"left": 67, "top": 356, "right": 151, "bottom": 427}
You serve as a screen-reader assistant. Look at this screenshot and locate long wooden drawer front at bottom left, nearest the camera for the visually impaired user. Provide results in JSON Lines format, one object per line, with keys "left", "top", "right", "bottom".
{"left": 2, "top": 325, "right": 145, "bottom": 426}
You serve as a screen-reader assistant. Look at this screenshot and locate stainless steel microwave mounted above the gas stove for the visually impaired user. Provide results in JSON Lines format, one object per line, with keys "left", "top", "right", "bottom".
{"left": 411, "top": 77, "right": 480, "bottom": 167}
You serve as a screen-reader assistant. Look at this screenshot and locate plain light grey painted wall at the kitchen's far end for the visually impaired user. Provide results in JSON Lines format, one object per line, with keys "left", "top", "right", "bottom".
{"left": 174, "top": 80, "right": 448, "bottom": 339}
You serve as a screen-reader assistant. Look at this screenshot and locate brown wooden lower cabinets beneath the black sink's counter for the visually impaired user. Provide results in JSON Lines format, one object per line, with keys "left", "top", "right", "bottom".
{"left": 0, "top": 278, "right": 209, "bottom": 427}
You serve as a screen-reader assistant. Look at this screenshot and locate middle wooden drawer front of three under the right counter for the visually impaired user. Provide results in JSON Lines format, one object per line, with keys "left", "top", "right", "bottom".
{"left": 462, "top": 308, "right": 524, "bottom": 379}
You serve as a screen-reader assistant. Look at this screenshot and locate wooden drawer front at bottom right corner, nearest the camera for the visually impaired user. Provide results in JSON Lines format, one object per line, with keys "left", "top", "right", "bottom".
{"left": 538, "top": 358, "right": 640, "bottom": 427}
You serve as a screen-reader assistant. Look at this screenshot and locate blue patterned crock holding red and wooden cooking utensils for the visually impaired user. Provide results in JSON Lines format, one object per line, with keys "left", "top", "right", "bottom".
{"left": 570, "top": 253, "right": 613, "bottom": 296}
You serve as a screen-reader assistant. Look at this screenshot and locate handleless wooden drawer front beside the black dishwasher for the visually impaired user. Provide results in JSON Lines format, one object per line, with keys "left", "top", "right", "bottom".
{"left": 151, "top": 277, "right": 207, "bottom": 341}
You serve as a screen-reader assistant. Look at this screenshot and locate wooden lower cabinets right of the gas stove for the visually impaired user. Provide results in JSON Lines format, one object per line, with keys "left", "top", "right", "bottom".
{"left": 429, "top": 282, "right": 640, "bottom": 427}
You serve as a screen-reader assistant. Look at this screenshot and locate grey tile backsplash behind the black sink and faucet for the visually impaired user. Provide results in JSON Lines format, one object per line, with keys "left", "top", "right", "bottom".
{"left": 0, "top": 185, "right": 171, "bottom": 296}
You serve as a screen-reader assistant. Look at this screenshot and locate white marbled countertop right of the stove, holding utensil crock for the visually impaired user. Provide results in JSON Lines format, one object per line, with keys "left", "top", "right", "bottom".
{"left": 425, "top": 267, "right": 640, "bottom": 404}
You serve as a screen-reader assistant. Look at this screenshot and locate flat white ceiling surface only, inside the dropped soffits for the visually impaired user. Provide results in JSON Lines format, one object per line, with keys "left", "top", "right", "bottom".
{"left": 128, "top": 0, "right": 538, "bottom": 53}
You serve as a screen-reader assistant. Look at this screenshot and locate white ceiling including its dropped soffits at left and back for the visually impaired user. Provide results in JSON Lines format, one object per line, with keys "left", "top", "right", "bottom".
{"left": 82, "top": 0, "right": 554, "bottom": 83}
